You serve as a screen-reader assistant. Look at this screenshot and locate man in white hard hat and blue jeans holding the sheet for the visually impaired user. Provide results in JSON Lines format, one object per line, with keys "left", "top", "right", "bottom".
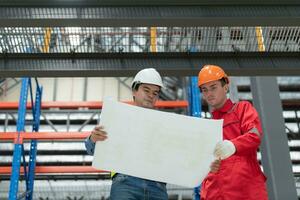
{"left": 85, "top": 68, "right": 168, "bottom": 200}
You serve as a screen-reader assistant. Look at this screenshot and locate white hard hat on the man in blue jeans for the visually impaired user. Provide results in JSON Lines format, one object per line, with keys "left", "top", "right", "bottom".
{"left": 131, "top": 68, "right": 163, "bottom": 88}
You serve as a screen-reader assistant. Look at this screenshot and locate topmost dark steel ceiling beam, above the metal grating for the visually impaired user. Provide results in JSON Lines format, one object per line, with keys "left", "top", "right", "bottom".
{"left": 0, "top": 4, "right": 300, "bottom": 27}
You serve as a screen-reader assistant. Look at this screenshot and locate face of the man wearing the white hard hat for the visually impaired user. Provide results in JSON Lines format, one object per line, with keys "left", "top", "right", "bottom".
{"left": 133, "top": 83, "right": 160, "bottom": 108}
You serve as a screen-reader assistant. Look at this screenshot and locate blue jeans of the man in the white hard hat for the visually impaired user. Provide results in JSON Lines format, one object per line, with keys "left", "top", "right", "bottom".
{"left": 110, "top": 174, "right": 168, "bottom": 200}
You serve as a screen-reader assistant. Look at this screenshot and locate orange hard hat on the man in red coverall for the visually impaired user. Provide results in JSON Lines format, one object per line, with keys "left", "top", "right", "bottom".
{"left": 198, "top": 65, "right": 229, "bottom": 87}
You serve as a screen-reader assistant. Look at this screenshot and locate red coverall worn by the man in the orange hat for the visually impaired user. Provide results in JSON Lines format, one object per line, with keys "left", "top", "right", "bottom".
{"left": 201, "top": 99, "right": 268, "bottom": 200}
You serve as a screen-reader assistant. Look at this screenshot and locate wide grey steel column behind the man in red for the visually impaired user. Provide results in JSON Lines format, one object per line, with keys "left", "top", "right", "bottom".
{"left": 251, "top": 77, "right": 298, "bottom": 200}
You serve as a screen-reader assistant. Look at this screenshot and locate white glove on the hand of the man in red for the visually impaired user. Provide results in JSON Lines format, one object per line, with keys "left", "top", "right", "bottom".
{"left": 214, "top": 140, "right": 236, "bottom": 160}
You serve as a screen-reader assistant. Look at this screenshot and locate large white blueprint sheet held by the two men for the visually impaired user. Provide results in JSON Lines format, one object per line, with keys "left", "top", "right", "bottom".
{"left": 93, "top": 99, "right": 223, "bottom": 187}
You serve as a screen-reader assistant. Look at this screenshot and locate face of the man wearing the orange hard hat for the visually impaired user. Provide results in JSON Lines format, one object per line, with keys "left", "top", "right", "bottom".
{"left": 200, "top": 81, "right": 228, "bottom": 109}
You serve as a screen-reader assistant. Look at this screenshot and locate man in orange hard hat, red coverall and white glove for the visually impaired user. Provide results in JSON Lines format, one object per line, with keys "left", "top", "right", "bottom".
{"left": 198, "top": 65, "right": 268, "bottom": 200}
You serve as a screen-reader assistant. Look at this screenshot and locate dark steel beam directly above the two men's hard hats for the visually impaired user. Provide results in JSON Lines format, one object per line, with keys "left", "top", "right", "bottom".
{"left": 0, "top": 52, "right": 300, "bottom": 78}
